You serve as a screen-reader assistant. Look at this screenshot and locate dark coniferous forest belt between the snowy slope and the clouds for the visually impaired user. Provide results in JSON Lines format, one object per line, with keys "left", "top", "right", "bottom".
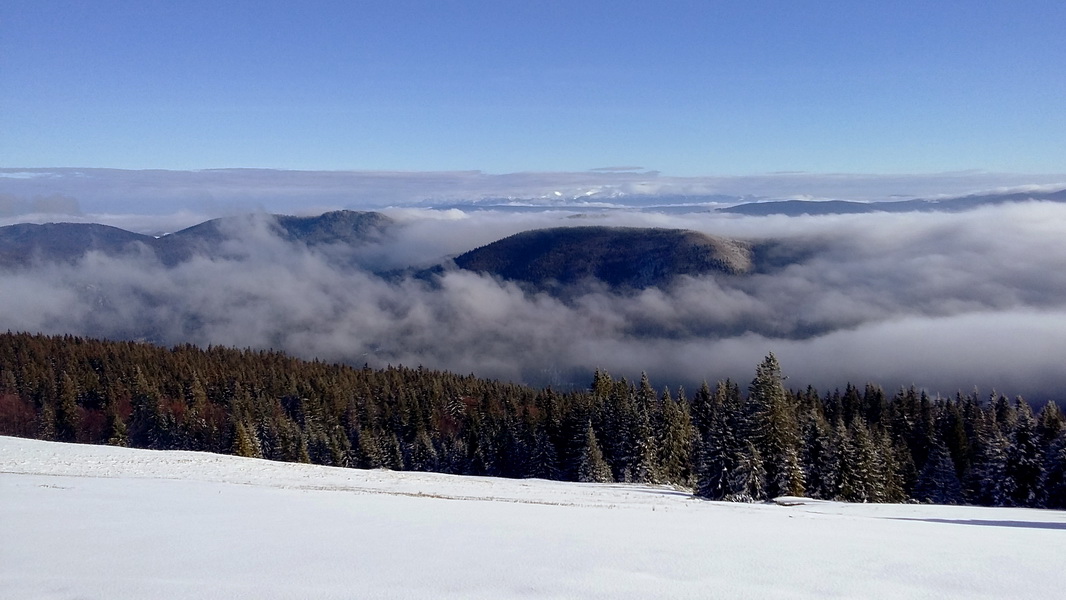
{"left": 0, "top": 333, "right": 1066, "bottom": 508}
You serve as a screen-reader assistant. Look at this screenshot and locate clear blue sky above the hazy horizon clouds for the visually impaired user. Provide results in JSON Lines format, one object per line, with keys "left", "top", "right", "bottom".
{"left": 0, "top": 0, "right": 1066, "bottom": 175}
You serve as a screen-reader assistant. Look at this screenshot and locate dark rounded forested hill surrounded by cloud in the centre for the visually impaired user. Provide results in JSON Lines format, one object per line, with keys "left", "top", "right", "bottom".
{"left": 455, "top": 227, "right": 754, "bottom": 289}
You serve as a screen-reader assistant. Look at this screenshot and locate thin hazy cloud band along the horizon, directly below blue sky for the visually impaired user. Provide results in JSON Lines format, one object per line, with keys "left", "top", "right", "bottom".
{"left": 8, "top": 168, "right": 1066, "bottom": 218}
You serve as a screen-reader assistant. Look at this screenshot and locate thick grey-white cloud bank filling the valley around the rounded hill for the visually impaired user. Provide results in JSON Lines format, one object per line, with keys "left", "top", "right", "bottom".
{"left": 0, "top": 202, "right": 1066, "bottom": 400}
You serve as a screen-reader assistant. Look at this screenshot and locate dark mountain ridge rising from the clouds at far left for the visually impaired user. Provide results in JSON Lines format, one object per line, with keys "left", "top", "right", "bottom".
{"left": 0, "top": 210, "right": 392, "bottom": 266}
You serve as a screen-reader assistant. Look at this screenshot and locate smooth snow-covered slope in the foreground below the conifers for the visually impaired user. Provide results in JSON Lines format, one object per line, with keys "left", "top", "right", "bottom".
{"left": 0, "top": 437, "right": 1066, "bottom": 599}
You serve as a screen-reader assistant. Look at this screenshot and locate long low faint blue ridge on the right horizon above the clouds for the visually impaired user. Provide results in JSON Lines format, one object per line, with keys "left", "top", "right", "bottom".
{"left": 717, "top": 190, "right": 1066, "bottom": 216}
